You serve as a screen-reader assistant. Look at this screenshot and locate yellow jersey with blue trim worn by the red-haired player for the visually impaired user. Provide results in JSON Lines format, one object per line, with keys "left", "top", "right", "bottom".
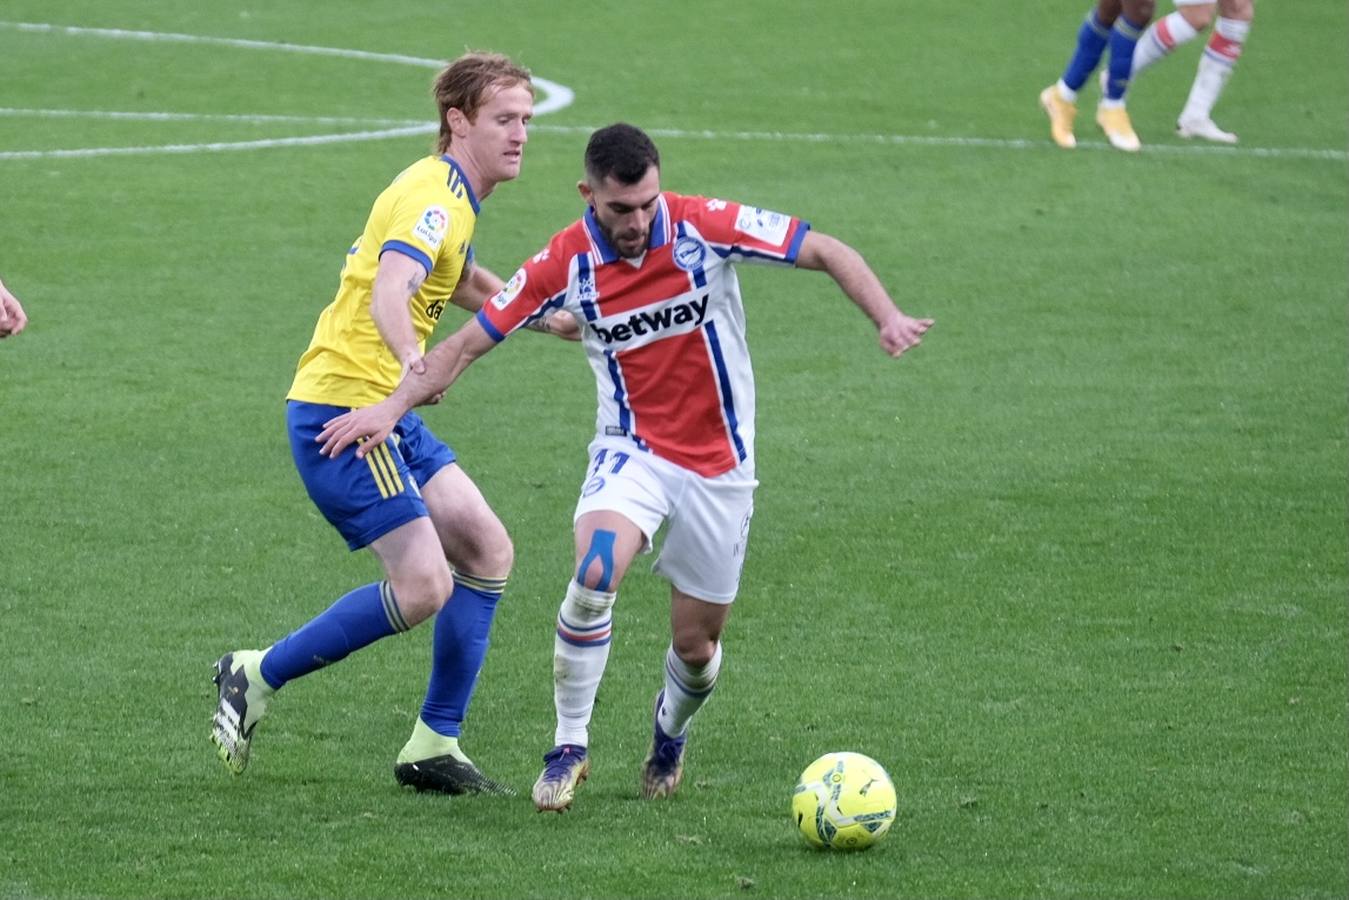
{"left": 286, "top": 157, "right": 478, "bottom": 406}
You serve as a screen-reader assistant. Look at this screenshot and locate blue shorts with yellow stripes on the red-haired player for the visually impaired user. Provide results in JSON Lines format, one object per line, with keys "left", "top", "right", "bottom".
{"left": 286, "top": 399, "right": 455, "bottom": 551}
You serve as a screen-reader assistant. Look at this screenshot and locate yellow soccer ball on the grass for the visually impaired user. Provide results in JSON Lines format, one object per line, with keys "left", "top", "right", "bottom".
{"left": 792, "top": 753, "right": 894, "bottom": 850}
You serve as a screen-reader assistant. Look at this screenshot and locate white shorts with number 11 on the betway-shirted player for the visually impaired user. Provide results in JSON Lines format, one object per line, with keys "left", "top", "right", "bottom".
{"left": 573, "top": 437, "right": 758, "bottom": 603}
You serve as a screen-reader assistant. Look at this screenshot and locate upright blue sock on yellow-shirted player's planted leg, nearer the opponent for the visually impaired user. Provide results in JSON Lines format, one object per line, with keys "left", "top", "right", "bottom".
{"left": 421, "top": 572, "right": 506, "bottom": 738}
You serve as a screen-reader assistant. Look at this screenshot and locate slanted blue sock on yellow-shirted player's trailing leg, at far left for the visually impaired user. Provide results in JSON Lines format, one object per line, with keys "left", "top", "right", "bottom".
{"left": 262, "top": 582, "right": 407, "bottom": 688}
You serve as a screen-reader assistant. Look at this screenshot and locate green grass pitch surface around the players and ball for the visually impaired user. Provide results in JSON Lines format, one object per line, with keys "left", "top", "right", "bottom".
{"left": 0, "top": 0, "right": 1349, "bottom": 899}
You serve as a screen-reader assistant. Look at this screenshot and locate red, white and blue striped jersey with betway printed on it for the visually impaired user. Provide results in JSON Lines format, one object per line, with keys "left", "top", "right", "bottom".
{"left": 478, "top": 192, "right": 809, "bottom": 478}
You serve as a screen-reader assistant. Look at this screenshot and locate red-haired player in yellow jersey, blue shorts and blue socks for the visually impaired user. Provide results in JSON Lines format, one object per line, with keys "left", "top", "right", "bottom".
{"left": 212, "top": 53, "right": 575, "bottom": 793}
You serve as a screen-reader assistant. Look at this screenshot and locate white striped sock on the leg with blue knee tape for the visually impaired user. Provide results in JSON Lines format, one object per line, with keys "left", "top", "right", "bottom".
{"left": 553, "top": 580, "right": 616, "bottom": 746}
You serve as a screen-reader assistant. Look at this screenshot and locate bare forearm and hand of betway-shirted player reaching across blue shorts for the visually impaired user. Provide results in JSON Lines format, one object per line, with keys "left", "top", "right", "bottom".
{"left": 314, "top": 318, "right": 496, "bottom": 459}
